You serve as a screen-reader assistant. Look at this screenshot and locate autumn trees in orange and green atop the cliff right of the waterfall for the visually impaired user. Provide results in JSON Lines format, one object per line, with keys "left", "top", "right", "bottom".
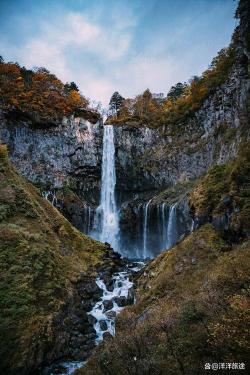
{"left": 108, "top": 38, "right": 237, "bottom": 127}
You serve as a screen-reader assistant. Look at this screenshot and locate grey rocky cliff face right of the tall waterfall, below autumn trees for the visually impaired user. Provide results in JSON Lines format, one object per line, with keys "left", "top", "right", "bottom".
{"left": 115, "top": 63, "right": 250, "bottom": 200}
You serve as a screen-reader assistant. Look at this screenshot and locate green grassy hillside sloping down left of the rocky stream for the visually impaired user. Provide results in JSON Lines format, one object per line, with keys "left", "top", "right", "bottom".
{"left": 0, "top": 145, "right": 109, "bottom": 374}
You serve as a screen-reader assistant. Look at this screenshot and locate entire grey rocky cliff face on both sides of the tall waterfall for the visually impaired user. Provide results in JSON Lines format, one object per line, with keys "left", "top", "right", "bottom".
{"left": 0, "top": 25, "right": 250, "bottom": 258}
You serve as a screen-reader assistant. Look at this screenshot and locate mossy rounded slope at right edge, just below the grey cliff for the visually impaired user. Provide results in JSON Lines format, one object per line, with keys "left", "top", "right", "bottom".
{"left": 190, "top": 142, "right": 250, "bottom": 240}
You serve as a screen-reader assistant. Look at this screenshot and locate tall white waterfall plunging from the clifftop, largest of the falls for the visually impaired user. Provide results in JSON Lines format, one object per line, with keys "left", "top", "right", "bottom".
{"left": 95, "top": 125, "right": 119, "bottom": 250}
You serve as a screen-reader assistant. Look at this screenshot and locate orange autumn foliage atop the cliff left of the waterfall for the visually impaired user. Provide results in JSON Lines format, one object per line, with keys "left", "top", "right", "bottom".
{"left": 0, "top": 60, "right": 92, "bottom": 122}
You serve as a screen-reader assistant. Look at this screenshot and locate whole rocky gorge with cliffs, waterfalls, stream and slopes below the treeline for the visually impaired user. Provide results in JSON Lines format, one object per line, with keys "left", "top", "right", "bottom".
{"left": 0, "top": 0, "right": 250, "bottom": 375}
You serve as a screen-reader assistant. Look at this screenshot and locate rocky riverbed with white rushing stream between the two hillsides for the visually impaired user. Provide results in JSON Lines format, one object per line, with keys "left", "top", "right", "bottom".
{"left": 42, "top": 260, "right": 144, "bottom": 375}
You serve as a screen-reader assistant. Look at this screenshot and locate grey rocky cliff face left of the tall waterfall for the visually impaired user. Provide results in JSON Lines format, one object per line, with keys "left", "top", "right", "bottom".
{"left": 1, "top": 114, "right": 103, "bottom": 201}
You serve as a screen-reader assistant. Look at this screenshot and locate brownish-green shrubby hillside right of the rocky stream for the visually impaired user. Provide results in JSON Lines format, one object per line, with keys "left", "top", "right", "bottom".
{"left": 77, "top": 145, "right": 250, "bottom": 375}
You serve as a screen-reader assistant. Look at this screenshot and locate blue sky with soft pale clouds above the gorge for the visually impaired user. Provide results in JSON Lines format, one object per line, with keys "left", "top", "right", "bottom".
{"left": 0, "top": 0, "right": 237, "bottom": 106}
